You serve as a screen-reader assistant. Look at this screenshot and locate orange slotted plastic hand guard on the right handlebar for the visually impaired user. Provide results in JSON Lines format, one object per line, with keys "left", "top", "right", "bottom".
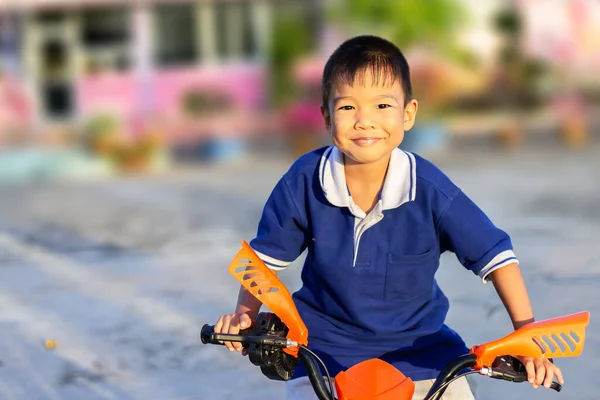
{"left": 470, "top": 311, "right": 590, "bottom": 369}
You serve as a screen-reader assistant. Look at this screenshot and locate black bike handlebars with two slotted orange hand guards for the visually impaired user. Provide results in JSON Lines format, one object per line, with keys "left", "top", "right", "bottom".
{"left": 200, "top": 241, "right": 590, "bottom": 400}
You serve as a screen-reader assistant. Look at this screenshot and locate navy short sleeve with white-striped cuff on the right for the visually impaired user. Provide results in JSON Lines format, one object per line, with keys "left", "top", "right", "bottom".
{"left": 439, "top": 191, "right": 519, "bottom": 282}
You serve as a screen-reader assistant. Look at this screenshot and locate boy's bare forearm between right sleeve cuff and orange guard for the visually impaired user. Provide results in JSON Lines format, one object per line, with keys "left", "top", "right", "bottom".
{"left": 489, "top": 263, "right": 534, "bottom": 329}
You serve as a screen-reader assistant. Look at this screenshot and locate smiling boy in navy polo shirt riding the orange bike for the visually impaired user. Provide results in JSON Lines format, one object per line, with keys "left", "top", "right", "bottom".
{"left": 215, "top": 36, "right": 563, "bottom": 400}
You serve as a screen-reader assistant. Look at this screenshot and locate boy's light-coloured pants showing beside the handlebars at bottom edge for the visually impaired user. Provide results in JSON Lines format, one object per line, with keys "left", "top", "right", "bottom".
{"left": 285, "top": 377, "right": 475, "bottom": 400}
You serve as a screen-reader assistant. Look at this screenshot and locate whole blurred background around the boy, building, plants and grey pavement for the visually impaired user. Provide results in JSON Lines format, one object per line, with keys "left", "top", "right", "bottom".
{"left": 0, "top": 0, "right": 600, "bottom": 400}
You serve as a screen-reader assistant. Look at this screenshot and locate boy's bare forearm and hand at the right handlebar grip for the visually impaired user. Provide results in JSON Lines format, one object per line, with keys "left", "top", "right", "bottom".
{"left": 489, "top": 263, "right": 564, "bottom": 388}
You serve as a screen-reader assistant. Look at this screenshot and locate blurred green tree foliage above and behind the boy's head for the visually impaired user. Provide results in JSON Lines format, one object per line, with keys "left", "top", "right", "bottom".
{"left": 271, "top": 0, "right": 474, "bottom": 104}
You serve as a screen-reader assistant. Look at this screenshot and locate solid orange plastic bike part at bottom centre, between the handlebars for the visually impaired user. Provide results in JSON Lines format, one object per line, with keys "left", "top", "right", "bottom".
{"left": 335, "top": 358, "right": 415, "bottom": 400}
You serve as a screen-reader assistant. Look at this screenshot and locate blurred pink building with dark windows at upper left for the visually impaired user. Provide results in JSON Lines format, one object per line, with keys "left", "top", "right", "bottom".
{"left": 0, "top": 0, "right": 271, "bottom": 143}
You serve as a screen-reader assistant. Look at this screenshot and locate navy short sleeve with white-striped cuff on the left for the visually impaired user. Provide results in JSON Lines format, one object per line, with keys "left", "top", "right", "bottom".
{"left": 250, "top": 178, "right": 306, "bottom": 270}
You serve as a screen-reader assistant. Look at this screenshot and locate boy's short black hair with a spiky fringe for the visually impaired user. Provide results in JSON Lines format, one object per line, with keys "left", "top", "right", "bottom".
{"left": 321, "top": 35, "right": 412, "bottom": 107}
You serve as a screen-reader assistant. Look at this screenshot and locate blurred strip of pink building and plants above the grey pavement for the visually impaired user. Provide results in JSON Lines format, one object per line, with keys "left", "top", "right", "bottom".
{"left": 0, "top": 0, "right": 600, "bottom": 172}
